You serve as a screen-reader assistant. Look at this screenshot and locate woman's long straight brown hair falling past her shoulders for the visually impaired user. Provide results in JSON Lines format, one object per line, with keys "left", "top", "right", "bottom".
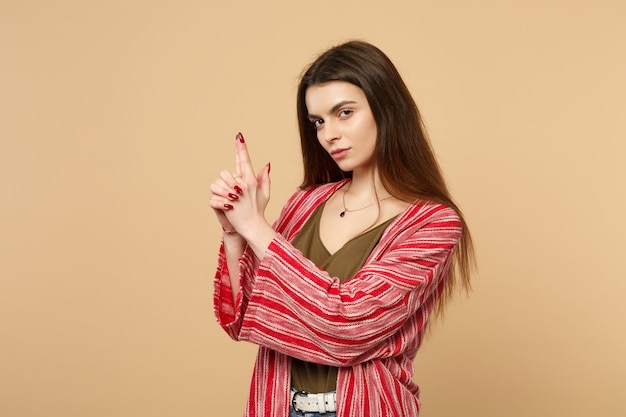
{"left": 297, "top": 41, "right": 474, "bottom": 315}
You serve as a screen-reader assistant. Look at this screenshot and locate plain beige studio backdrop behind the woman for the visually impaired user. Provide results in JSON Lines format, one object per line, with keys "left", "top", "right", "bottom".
{"left": 0, "top": 0, "right": 626, "bottom": 417}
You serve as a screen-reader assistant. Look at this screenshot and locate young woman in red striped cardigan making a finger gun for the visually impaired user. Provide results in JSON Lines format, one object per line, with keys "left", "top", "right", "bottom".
{"left": 210, "top": 41, "right": 473, "bottom": 417}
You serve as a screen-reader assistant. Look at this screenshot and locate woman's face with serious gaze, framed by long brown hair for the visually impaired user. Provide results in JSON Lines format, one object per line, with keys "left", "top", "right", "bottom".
{"left": 305, "top": 81, "right": 377, "bottom": 174}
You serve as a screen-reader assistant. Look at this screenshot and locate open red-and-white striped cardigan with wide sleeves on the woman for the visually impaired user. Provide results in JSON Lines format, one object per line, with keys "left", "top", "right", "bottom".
{"left": 214, "top": 180, "right": 461, "bottom": 417}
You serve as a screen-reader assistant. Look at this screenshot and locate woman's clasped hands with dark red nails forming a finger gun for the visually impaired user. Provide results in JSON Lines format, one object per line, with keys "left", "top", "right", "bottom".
{"left": 209, "top": 133, "right": 274, "bottom": 255}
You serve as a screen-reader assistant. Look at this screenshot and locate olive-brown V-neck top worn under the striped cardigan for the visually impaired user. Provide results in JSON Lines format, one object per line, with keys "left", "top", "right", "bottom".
{"left": 291, "top": 203, "right": 395, "bottom": 393}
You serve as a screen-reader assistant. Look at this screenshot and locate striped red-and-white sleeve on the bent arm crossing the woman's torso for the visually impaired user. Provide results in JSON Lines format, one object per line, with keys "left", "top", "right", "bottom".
{"left": 234, "top": 205, "right": 461, "bottom": 366}
